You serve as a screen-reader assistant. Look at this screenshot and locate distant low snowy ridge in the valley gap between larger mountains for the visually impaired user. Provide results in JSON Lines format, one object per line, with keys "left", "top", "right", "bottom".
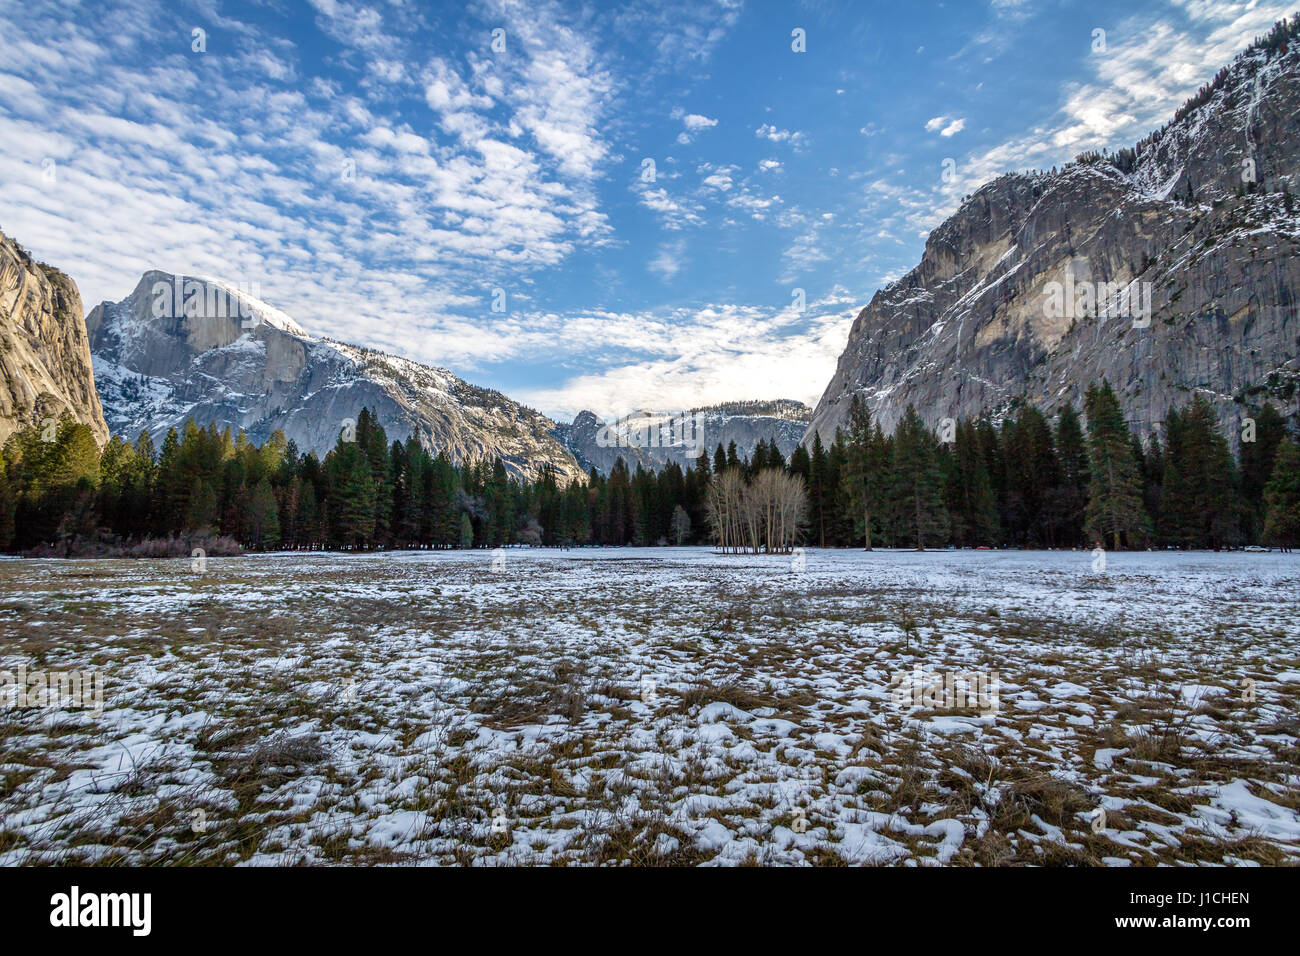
{"left": 553, "top": 399, "right": 811, "bottom": 475}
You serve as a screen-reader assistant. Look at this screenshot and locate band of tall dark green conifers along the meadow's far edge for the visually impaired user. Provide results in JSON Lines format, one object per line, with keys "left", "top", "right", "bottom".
{"left": 0, "top": 382, "right": 1300, "bottom": 554}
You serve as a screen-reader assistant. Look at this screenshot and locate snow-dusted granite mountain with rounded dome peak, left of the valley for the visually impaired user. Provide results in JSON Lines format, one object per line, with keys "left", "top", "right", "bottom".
{"left": 86, "top": 272, "right": 582, "bottom": 480}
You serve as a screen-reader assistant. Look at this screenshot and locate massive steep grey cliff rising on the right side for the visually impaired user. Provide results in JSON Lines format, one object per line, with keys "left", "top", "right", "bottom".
{"left": 805, "top": 27, "right": 1300, "bottom": 441}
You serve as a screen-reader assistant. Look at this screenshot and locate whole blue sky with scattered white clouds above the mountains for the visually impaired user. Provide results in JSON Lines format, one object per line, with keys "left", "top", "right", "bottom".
{"left": 0, "top": 0, "right": 1291, "bottom": 418}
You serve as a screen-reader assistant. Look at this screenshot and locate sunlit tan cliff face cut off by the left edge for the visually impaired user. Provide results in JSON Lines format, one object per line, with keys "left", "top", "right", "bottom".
{"left": 0, "top": 228, "right": 108, "bottom": 445}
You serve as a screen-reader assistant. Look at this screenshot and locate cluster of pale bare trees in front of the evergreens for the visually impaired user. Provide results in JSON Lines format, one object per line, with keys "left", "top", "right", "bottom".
{"left": 707, "top": 468, "right": 809, "bottom": 554}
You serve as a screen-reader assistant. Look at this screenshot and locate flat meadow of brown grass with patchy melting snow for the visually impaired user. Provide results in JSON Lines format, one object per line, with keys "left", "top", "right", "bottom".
{"left": 0, "top": 549, "right": 1300, "bottom": 865}
